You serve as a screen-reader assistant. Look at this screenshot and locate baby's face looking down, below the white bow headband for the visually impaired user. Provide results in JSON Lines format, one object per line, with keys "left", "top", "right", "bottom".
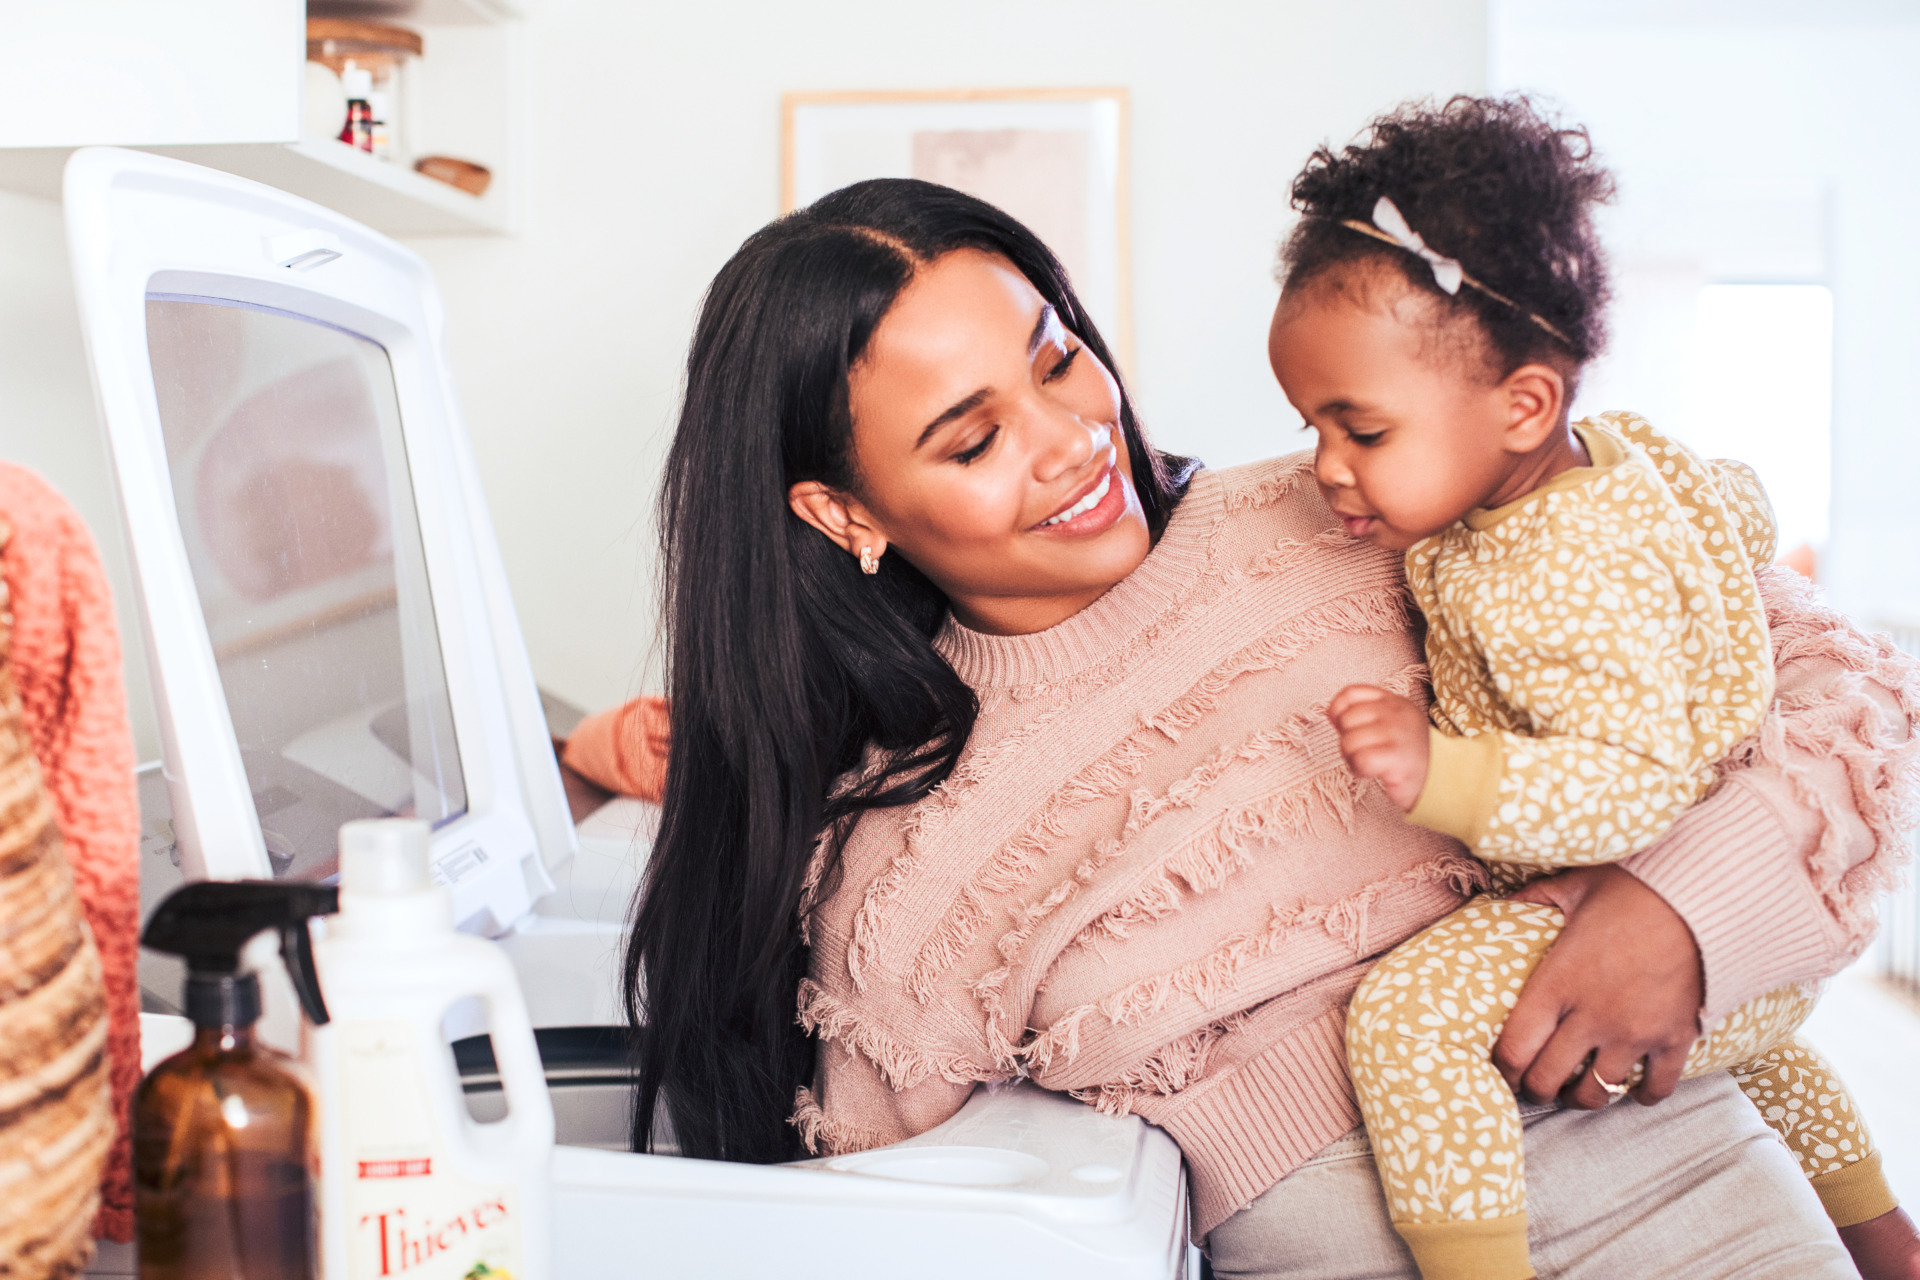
{"left": 1267, "top": 273, "right": 1513, "bottom": 551}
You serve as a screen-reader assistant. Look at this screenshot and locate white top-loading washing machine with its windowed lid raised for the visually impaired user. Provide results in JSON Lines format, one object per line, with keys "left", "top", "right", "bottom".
{"left": 65, "top": 148, "right": 1196, "bottom": 1280}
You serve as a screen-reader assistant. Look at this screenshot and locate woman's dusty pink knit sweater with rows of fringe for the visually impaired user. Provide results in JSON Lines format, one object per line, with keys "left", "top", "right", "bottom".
{"left": 795, "top": 455, "right": 1920, "bottom": 1234}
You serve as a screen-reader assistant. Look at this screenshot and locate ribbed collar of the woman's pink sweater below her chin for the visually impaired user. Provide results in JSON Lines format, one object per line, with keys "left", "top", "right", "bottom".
{"left": 933, "top": 470, "right": 1227, "bottom": 689}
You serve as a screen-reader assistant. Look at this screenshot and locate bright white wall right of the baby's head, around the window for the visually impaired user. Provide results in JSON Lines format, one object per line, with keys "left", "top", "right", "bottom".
{"left": 1492, "top": 0, "right": 1920, "bottom": 624}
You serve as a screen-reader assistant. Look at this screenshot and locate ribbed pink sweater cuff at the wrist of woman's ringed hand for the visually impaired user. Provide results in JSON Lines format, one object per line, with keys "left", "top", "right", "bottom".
{"left": 1622, "top": 781, "right": 1834, "bottom": 1027}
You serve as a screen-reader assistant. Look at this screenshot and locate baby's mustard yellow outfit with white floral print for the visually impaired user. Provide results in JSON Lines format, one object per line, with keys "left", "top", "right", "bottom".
{"left": 1348, "top": 413, "right": 1893, "bottom": 1280}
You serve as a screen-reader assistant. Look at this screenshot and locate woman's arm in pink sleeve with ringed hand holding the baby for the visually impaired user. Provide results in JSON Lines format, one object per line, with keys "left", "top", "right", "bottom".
{"left": 1494, "top": 568, "right": 1920, "bottom": 1107}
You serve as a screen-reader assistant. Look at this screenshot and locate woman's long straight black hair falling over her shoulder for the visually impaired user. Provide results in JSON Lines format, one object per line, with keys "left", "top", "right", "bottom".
{"left": 622, "top": 178, "right": 1190, "bottom": 1163}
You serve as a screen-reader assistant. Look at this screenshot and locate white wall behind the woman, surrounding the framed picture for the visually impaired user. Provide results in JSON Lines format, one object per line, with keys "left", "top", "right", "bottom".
{"left": 0, "top": 0, "right": 1486, "bottom": 741}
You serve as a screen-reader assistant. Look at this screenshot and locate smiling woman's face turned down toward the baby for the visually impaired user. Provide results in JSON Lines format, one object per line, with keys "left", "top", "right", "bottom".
{"left": 791, "top": 249, "right": 1150, "bottom": 635}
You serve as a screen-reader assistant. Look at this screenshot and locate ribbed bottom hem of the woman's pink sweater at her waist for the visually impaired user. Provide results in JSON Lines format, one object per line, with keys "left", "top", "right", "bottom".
{"left": 1154, "top": 1000, "right": 1359, "bottom": 1240}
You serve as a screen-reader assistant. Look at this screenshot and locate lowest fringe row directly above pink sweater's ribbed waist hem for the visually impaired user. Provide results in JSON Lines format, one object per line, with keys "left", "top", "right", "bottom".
{"left": 1016, "top": 854, "right": 1486, "bottom": 1075}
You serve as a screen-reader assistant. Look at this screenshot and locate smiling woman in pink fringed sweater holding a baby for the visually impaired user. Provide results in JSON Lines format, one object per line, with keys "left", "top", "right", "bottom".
{"left": 587, "top": 180, "right": 1912, "bottom": 1276}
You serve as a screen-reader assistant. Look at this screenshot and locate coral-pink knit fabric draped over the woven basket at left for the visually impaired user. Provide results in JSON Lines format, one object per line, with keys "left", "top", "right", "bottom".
{"left": 0, "top": 462, "right": 140, "bottom": 1240}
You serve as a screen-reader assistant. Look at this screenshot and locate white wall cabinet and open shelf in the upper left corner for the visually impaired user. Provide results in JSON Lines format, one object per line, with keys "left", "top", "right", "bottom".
{"left": 0, "top": 0, "right": 520, "bottom": 236}
